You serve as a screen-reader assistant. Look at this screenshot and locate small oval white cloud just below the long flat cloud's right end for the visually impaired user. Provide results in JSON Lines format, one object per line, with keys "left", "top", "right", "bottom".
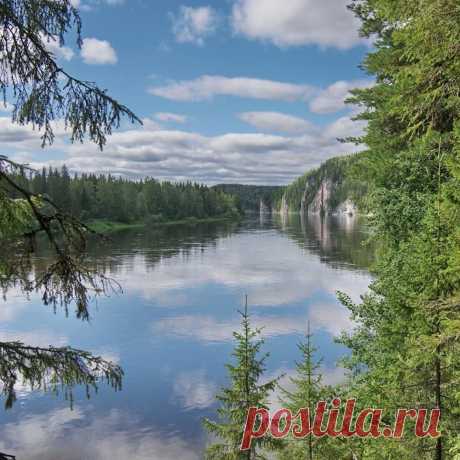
{"left": 238, "top": 112, "right": 315, "bottom": 133}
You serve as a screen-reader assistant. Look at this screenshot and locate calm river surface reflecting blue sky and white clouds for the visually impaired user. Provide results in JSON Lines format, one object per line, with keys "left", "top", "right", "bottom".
{"left": 0, "top": 216, "right": 370, "bottom": 460}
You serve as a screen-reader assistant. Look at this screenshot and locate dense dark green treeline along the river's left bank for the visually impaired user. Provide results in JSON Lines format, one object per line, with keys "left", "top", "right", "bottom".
{"left": 10, "top": 166, "right": 240, "bottom": 223}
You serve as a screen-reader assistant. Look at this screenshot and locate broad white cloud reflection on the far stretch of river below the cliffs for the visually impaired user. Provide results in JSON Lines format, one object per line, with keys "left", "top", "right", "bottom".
{"left": 96, "top": 217, "right": 368, "bottom": 307}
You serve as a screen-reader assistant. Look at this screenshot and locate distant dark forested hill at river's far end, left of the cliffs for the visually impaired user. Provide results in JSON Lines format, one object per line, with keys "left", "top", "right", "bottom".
{"left": 213, "top": 184, "right": 285, "bottom": 212}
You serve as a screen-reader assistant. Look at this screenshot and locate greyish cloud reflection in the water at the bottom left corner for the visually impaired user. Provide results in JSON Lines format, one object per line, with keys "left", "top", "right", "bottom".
{"left": 0, "top": 407, "right": 201, "bottom": 460}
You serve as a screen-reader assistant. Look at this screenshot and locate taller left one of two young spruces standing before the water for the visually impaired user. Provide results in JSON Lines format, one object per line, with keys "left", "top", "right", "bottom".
{"left": 204, "top": 296, "right": 279, "bottom": 460}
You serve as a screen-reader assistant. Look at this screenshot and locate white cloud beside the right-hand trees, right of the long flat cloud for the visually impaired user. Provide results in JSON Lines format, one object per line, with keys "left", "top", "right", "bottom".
{"left": 309, "top": 80, "right": 373, "bottom": 113}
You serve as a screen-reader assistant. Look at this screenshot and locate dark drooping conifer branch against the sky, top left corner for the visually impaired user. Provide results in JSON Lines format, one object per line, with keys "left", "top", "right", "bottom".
{"left": 0, "top": 0, "right": 142, "bottom": 149}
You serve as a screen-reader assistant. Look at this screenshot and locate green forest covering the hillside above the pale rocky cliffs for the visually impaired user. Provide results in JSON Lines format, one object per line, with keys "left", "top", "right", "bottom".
{"left": 275, "top": 154, "right": 368, "bottom": 212}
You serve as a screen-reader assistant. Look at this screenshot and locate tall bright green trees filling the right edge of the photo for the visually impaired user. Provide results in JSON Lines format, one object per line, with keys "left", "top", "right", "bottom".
{"left": 334, "top": 0, "right": 460, "bottom": 460}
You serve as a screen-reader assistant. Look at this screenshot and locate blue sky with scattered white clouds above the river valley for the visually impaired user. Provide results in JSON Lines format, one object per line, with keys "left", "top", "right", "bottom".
{"left": 0, "top": 0, "right": 372, "bottom": 185}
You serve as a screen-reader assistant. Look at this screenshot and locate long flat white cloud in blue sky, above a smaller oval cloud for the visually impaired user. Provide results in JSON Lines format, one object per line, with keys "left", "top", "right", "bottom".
{"left": 149, "top": 75, "right": 313, "bottom": 101}
